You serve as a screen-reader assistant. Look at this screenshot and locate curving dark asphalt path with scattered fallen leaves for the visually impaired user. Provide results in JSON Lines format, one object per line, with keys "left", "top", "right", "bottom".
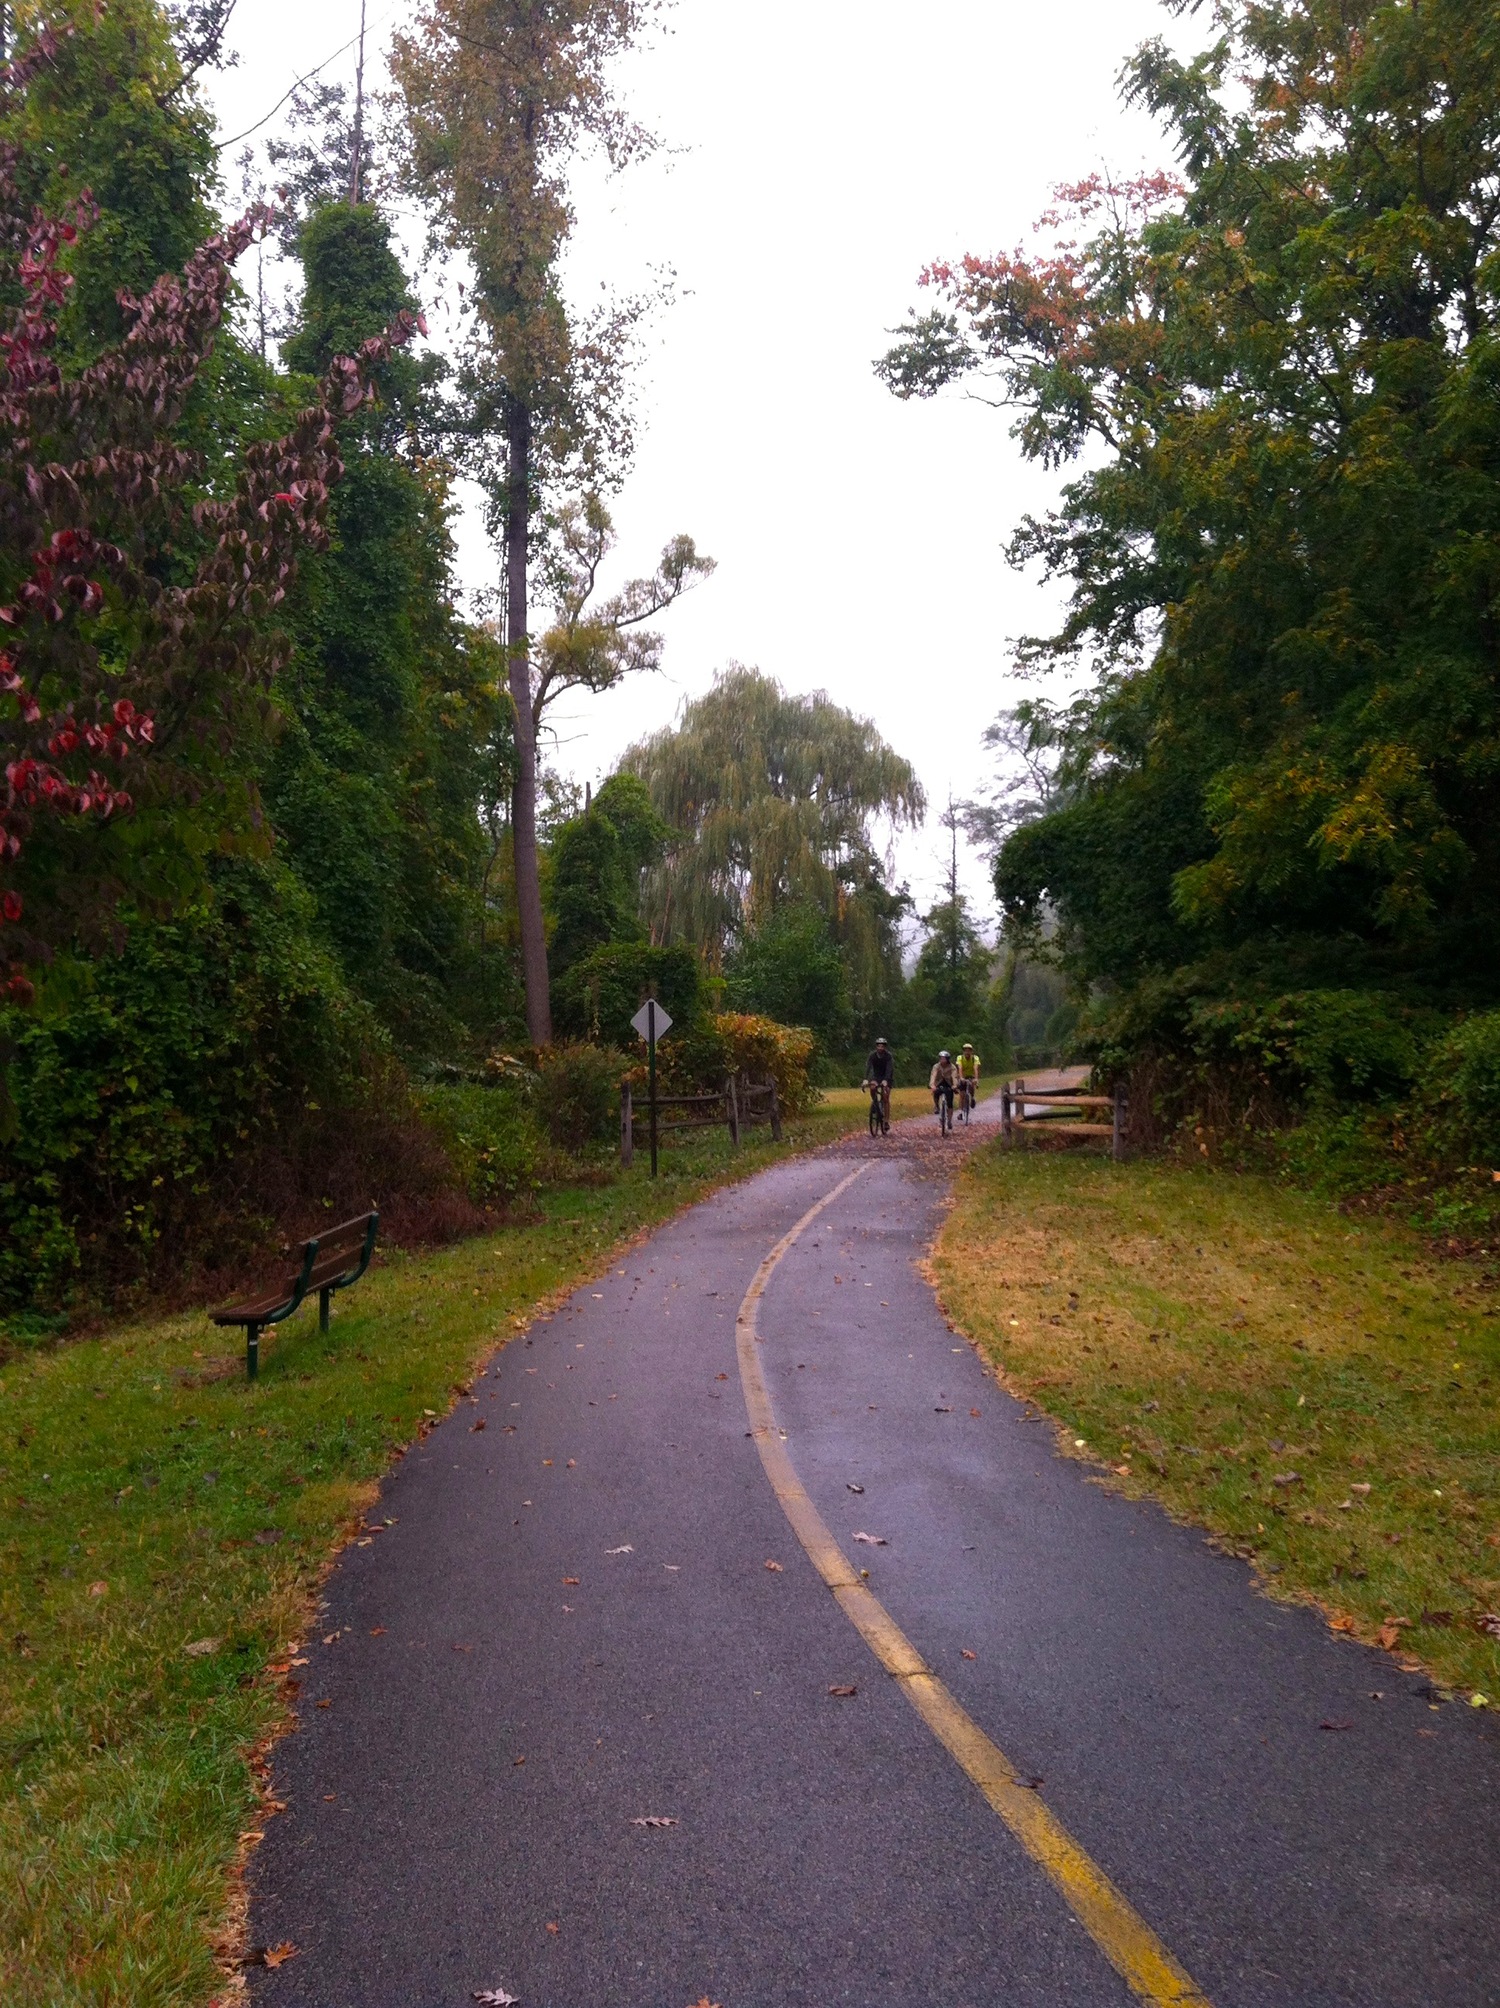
{"left": 251, "top": 1102, "right": 1500, "bottom": 2008}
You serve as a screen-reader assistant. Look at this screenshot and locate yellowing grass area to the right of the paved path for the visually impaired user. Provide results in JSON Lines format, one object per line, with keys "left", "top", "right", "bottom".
{"left": 934, "top": 1149, "right": 1500, "bottom": 1705}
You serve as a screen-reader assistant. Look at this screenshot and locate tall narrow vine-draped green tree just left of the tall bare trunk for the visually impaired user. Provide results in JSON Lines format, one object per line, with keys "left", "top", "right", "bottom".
{"left": 265, "top": 205, "right": 510, "bottom": 1052}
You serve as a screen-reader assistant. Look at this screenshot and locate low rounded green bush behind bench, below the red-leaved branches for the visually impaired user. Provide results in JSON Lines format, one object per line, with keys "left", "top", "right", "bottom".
{"left": 0, "top": 861, "right": 386, "bottom": 1307}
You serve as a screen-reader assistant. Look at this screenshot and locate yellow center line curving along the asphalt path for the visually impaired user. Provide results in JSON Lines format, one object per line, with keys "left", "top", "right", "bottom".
{"left": 735, "top": 1165, "right": 1211, "bottom": 2008}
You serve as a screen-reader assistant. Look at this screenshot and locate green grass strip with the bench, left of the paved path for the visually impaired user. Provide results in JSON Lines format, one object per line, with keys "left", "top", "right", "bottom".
{"left": 0, "top": 1108, "right": 849, "bottom": 2008}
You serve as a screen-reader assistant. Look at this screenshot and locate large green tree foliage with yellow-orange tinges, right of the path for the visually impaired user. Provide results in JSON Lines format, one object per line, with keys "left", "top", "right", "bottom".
{"left": 882, "top": 0, "right": 1500, "bottom": 1188}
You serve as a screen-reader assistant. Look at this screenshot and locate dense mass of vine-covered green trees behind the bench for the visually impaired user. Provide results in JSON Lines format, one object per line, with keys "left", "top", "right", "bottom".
{"left": 0, "top": 0, "right": 518, "bottom": 1305}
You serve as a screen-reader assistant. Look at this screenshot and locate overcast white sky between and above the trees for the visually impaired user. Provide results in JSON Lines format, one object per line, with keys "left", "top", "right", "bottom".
{"left": 209, "top": 0, "right": 1201, "bottom": 935}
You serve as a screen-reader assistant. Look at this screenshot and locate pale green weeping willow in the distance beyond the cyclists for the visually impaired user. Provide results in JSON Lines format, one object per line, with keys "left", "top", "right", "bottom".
{"left": 622, "top": 665, "right": 926, "bottom": 1012}
